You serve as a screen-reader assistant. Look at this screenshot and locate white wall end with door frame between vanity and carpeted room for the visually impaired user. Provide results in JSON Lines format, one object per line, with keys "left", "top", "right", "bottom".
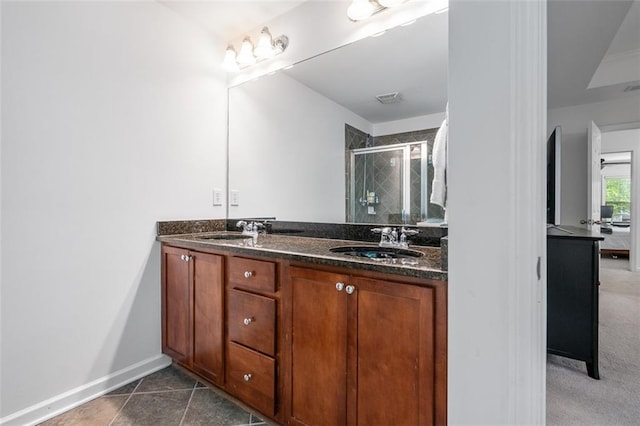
{"left": 447, "top": 0, "right": 547, "bottom": 424}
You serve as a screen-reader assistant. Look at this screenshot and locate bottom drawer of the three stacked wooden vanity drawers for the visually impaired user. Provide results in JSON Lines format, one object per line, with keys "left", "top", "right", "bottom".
{"left": 227, "top": 342, "right": 276, "bottom": 416}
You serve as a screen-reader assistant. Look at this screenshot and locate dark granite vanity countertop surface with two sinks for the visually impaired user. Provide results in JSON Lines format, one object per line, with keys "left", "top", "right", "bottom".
{"left": 156, "top": 232, "right": 447, "bottom": 281}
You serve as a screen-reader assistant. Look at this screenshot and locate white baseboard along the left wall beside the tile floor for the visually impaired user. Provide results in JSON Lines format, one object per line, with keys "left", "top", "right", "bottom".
{"left": 0, "top": 355, "right": 171, "bottom": 426}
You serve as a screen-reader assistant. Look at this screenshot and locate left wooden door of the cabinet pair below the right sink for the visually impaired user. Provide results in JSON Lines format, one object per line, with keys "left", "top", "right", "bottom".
{"left": 289, "top": 268, "right": 347, "bottom": 425}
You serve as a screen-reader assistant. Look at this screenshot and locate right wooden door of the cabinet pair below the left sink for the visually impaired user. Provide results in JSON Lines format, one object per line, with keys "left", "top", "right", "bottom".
{"left": 192, "top": 253, "right": 224, "bottom": 384}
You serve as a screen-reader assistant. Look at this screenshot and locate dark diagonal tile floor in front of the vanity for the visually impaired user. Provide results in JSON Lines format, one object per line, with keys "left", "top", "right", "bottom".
{"left": 41, "top": 366, "right": 267, "bottom": 426}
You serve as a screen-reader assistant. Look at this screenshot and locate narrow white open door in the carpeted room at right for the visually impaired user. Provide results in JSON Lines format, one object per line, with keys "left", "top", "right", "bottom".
{"left": 586, "top": 121, "right": 602, "bottom": 232}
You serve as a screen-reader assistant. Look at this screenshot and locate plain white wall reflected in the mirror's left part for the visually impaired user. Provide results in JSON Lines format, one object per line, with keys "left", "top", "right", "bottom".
{"left": 229, "top": 73, "right": 371, "bottom": 222}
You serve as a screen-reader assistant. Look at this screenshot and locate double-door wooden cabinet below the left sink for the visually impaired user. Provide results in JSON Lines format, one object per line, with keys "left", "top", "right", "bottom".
{"left": 162, "top": 245, "right": 224, "bottom": 384}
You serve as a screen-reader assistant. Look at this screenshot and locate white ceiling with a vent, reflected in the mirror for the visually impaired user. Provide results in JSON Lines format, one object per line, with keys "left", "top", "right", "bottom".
{"left": 284, "top": 13, "right": 448, "bottom": 123}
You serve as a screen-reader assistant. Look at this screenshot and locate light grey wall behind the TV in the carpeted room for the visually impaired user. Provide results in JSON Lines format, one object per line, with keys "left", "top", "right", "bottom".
{"left": 547, "top": 95, "right": 640, "bottom": 226}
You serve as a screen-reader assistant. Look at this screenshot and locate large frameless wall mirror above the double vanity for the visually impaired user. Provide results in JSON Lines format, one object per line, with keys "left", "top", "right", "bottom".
{"left": 228, "top": 12, "right": 448, "bottom": 224}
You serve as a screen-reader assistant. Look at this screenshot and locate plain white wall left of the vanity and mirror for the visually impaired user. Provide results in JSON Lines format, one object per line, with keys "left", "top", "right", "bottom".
{"left": 0, "top": 2, "right": 226, "bottom": 424}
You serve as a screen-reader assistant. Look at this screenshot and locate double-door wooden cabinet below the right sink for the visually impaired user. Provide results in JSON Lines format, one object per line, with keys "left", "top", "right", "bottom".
{"left": 288, "top": 267, "right": 446, "bottom": 425}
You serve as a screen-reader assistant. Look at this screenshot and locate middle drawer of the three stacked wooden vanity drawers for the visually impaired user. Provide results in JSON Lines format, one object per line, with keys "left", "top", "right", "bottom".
{"left": 228, "top": 289, "right": 276, "bottom": 356}
